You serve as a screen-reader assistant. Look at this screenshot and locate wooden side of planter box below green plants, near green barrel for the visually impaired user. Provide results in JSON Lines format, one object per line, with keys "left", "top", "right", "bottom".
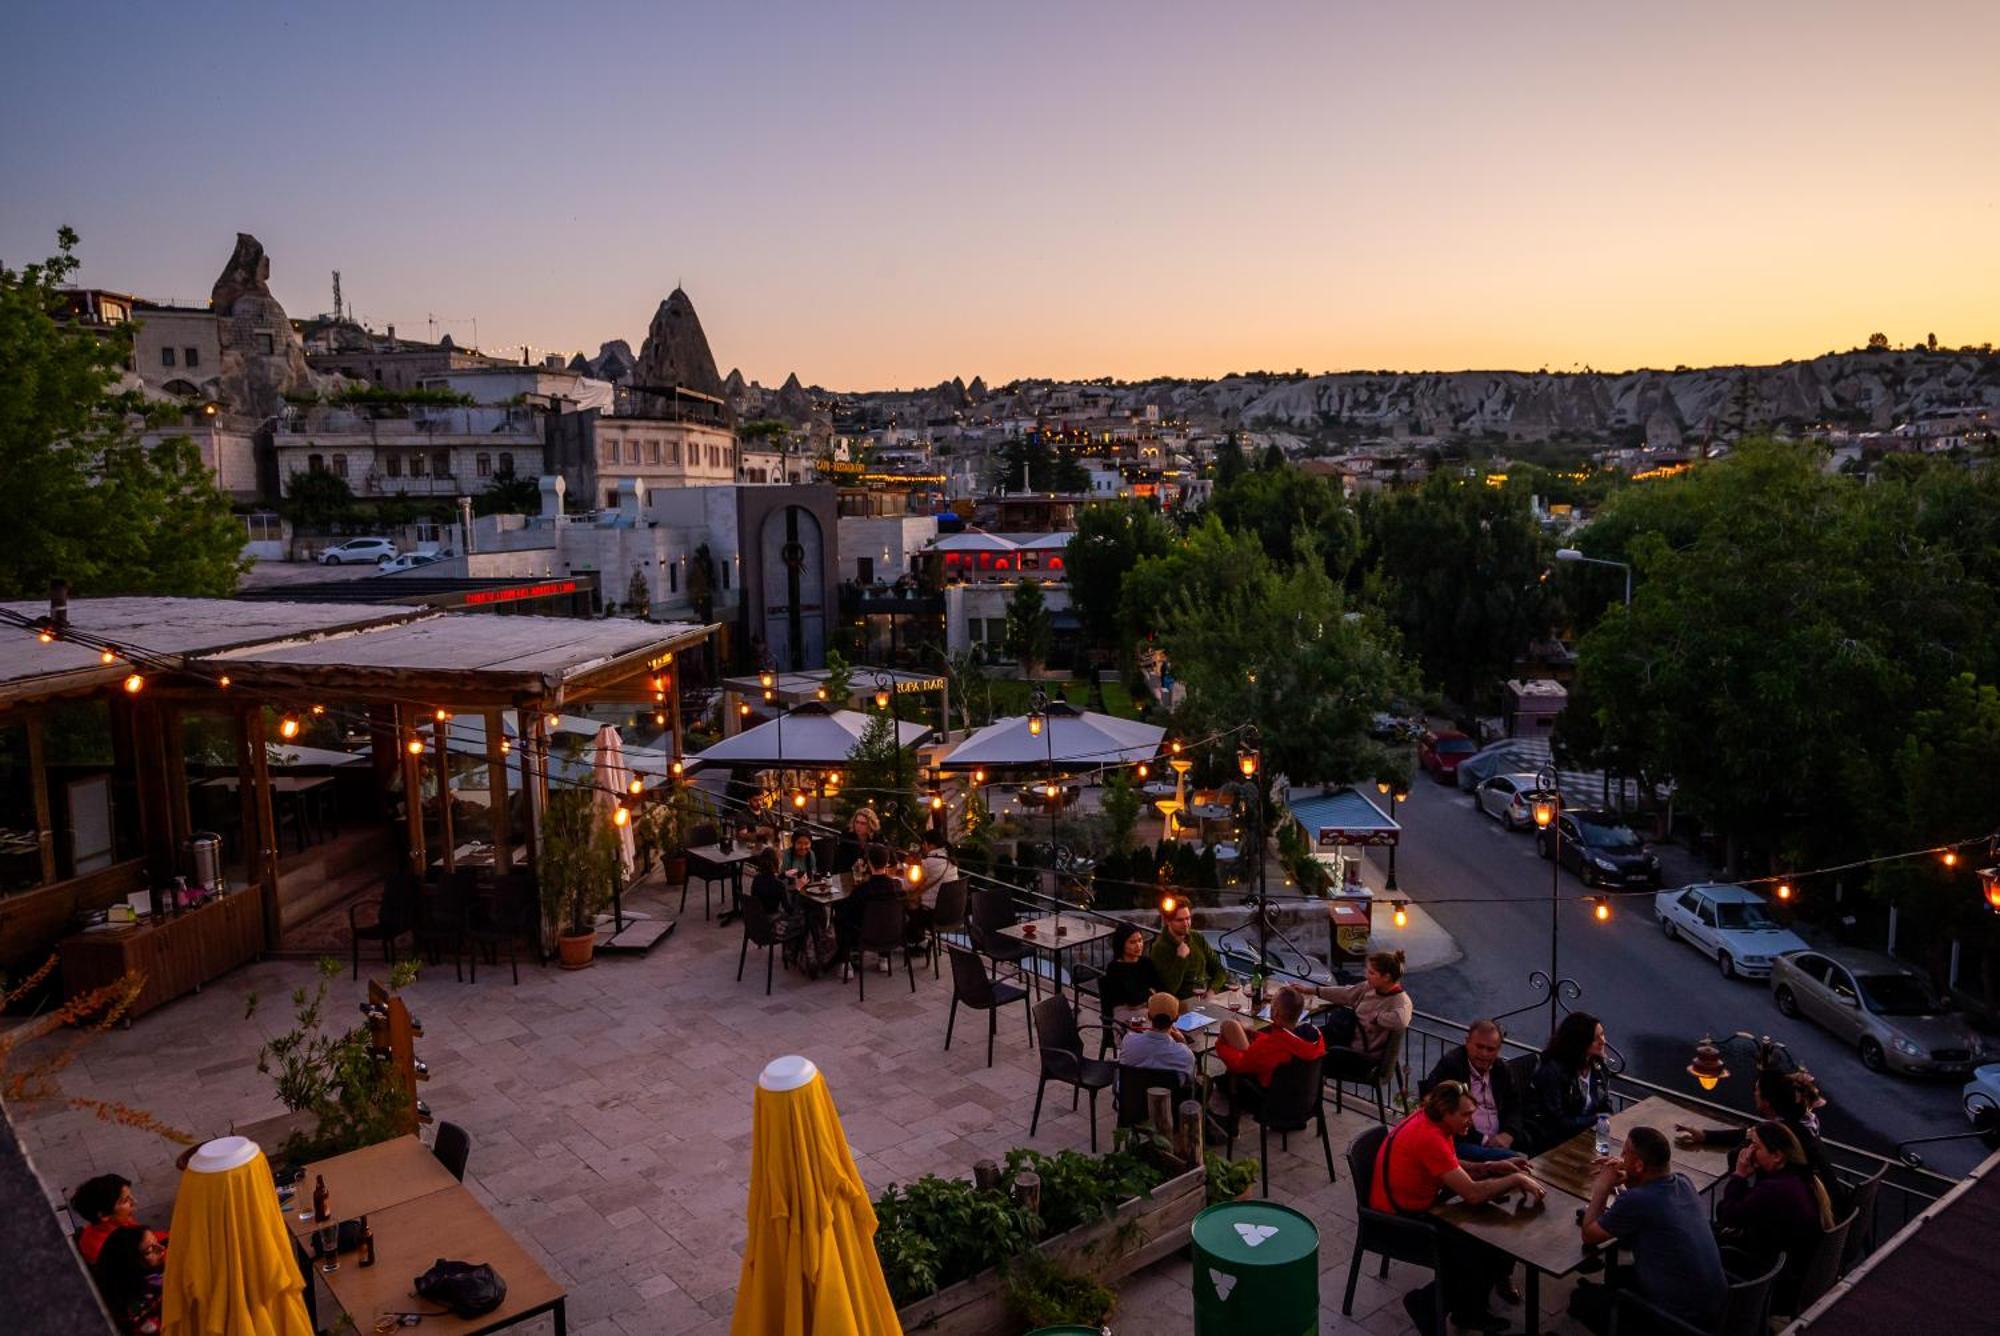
{"left": 896, "top": 1168, "right": 1208, "bottom": 1336}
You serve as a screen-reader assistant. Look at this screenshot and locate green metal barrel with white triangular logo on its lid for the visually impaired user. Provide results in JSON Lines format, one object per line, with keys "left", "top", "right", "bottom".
{"left": 1190, "top": 1202, "right": 1320, "bottom": 1336}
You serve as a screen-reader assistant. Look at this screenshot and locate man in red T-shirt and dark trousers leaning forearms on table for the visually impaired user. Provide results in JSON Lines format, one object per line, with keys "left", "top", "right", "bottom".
{"left": 1368, "top": 1080, "right": 1546, "bottom": 1336}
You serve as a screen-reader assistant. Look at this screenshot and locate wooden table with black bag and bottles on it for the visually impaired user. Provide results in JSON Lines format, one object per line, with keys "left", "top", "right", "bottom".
{"left": 286, "top": 1136, "right": 568, "bottom": 1336}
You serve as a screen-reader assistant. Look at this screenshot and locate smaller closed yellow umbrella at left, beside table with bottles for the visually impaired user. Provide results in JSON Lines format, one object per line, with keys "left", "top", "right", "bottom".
{"left": 160, "top": 1136, "right": 312, "bottom": 1336}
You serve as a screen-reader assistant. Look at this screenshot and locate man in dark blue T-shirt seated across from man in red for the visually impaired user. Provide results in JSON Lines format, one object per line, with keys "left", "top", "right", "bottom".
{"left": 1570, "top": 1128, "right": 1730, "bottom": 1336}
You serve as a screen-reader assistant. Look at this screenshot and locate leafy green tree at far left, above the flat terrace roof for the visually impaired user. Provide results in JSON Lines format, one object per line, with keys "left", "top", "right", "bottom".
{"left": 0, "top": 228, "right": 244, "bottom": 596}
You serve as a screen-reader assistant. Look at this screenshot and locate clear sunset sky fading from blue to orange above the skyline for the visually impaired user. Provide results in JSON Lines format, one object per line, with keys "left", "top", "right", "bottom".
{"left": 0, "top": 0, "right": 2000, "bottom": 390}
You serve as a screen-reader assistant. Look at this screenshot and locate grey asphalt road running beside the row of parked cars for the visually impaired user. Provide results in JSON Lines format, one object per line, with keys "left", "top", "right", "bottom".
{"left": 1396, "top": 776, "right": 1984, "bottom": 1174}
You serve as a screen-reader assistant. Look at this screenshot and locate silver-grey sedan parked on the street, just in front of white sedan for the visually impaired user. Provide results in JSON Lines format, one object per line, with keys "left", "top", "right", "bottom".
{"left": 1770, "top": 950, "right": 1986, "bottom": 1076}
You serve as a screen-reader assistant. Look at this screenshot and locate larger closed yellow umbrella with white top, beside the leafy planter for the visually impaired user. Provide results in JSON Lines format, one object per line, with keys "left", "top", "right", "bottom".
{"left": 732, "top": 1058, "right": 902, "bottom": 1336}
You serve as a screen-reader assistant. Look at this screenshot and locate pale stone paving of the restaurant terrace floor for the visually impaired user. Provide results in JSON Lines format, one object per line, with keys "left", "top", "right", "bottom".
{"left": 16, "top": 876, "right": 1592, "bottom": 1336}
